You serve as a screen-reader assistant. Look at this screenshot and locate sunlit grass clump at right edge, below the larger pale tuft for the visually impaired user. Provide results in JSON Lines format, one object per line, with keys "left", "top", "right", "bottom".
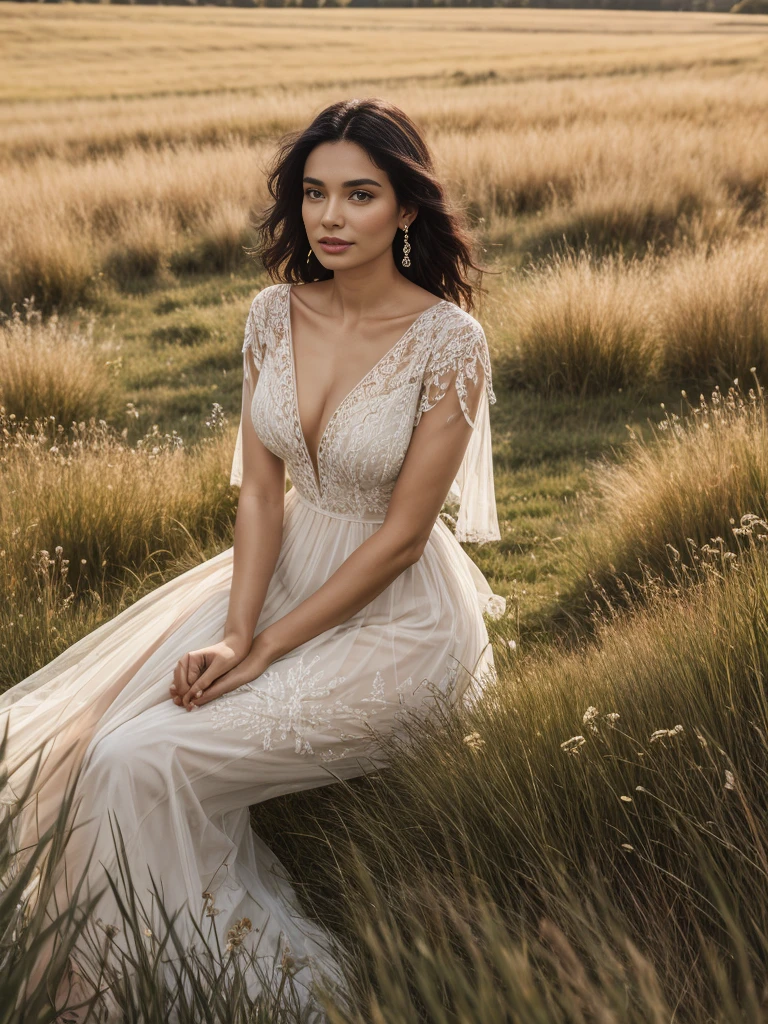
{"left": 570, "top": 372, "right": 768, "bottom": 609}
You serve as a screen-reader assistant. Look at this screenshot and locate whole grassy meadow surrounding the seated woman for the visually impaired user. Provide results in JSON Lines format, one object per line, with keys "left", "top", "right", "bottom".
{"left": 0, "top": 3, "right": 768, "bottom": 1024}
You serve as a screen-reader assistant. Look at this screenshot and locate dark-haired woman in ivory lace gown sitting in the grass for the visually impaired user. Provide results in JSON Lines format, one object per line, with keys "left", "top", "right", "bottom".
{"left": 0, "top": 94, "right": 505, "bottom": 1005}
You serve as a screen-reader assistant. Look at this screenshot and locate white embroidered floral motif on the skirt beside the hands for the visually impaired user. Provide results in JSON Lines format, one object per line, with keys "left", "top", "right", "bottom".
{"left": 211, "top": 654, "right": 413, "bottom": 761}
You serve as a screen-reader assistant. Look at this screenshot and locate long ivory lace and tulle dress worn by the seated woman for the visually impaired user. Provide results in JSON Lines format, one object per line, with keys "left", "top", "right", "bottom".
{"left": 0, "top": 284, "right": 505, "bottom": 1007}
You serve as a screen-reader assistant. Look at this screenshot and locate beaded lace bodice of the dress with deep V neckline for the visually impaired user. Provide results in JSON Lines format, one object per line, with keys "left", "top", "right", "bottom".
{"left": 231, "top": 284, "right": 498, "bottom": 540}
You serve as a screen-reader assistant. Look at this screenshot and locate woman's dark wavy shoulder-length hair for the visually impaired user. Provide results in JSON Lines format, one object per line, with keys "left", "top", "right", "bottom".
{"left": 252, "top": 98, "right": 487, "bottom": 312}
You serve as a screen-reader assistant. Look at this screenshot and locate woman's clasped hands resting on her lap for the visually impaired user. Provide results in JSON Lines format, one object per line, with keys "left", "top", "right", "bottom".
{"left": 171, "top": 636, "right": 273, "bottom": 711}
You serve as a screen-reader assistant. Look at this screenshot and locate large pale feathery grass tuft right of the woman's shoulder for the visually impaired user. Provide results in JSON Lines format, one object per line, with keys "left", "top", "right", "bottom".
{"left": 501, "top": 232, "right": 768, "bottom": 396}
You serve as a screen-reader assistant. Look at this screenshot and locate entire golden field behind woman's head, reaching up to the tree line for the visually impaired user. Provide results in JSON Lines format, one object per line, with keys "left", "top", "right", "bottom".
{"left": 0, "top": 4, "right": 768, "bottom": 309}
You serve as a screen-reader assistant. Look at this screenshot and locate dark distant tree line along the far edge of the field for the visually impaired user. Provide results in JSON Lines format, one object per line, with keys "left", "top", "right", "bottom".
{"left": 9, "top": 0, "right": 768, "bottom": 14}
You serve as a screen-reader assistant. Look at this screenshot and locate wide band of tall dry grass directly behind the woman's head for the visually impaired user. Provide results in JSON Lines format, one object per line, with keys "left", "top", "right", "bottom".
{"left": 0, "top": 72, "right": 768, "bottom": 310}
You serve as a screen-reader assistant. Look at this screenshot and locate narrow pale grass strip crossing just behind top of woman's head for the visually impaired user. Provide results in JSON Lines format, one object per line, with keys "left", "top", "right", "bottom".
{"left": 0, "top": 63, "right": 766, "bottom": 164}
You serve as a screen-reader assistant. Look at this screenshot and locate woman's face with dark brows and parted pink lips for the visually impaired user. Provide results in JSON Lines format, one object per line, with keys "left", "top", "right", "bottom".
{"left": 301, "top": 141, "right": 415, "bottom": 270}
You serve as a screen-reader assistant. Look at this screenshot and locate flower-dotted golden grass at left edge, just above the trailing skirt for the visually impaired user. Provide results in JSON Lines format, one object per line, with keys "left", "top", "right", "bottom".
{"left": 0, "top": 410, "right": 237, "bottom": 689}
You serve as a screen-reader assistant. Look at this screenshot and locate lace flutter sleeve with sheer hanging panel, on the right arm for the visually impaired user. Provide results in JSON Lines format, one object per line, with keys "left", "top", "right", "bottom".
{"left": 414, "top": 311, "right": 501, "bottom": 544}
